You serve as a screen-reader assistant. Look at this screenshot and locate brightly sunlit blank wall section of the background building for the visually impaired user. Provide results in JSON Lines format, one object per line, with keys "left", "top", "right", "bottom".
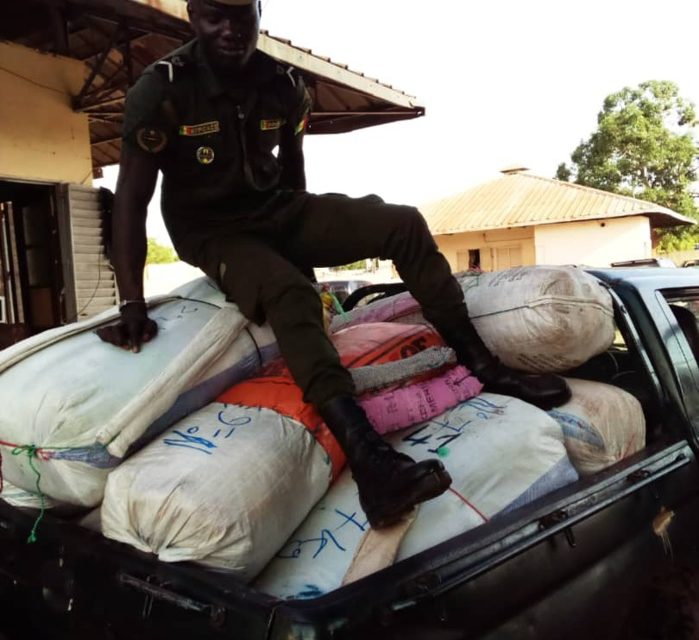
{"left": 534, "top": 216, "right": 651, "bottom": 267}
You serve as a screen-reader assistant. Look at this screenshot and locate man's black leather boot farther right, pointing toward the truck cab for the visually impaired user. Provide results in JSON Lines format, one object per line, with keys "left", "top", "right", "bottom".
{"left": 436, "top": 319, "right": 570, "bottom": 410}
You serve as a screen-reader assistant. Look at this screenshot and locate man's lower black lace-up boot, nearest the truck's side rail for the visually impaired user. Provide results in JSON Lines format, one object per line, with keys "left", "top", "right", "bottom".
{"left": 318, "top": 396, "right": 451, "bottom": 529}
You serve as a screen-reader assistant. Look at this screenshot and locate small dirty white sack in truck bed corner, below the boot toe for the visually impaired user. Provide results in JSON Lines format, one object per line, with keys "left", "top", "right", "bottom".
{"left": 548, "top": 378, "right": 646, "bottom": 475}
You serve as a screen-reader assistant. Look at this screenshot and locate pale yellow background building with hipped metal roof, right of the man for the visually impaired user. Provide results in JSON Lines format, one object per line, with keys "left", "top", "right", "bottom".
{"left": 421, "top": 169, "right": 695, "bottom": 271}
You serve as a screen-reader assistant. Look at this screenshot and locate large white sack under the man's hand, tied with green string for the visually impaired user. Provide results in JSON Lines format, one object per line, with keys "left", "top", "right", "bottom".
{"left": 0, "top": 278, "right": 277, "bottom": 507}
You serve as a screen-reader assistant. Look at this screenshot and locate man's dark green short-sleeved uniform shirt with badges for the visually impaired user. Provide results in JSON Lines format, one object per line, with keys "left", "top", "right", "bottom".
{"left": 123, "top": 40, "right": 310, "bottom": 259}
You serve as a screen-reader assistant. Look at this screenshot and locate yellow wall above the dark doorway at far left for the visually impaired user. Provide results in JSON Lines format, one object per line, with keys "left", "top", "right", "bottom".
{"left": 0, "top": 42, "right": 92, "bottom": 186}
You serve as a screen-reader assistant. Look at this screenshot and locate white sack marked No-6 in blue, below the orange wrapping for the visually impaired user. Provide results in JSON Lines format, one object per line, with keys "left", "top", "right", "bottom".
{"left": 101, "top": 403, "right": 332, "bottom": 580}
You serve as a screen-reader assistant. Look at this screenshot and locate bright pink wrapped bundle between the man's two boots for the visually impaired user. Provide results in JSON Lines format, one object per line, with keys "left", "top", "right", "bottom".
{"left": 359, "top": 366, "right": 483, "bottom": 435}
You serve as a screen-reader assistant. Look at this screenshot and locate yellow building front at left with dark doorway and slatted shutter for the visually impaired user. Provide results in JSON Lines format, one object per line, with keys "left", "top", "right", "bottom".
{"left": 0, "top": 42, "right": 103, "bottom": 342}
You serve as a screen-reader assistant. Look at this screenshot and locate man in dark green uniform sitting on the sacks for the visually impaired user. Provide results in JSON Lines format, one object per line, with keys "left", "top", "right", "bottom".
{"left": 100, "top": 0, "right": 570, "bottom": 528}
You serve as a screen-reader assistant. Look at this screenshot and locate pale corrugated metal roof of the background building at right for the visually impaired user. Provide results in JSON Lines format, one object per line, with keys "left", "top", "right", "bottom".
{"left": 420, "top": 171, "right": 696, "bottom": 235}
